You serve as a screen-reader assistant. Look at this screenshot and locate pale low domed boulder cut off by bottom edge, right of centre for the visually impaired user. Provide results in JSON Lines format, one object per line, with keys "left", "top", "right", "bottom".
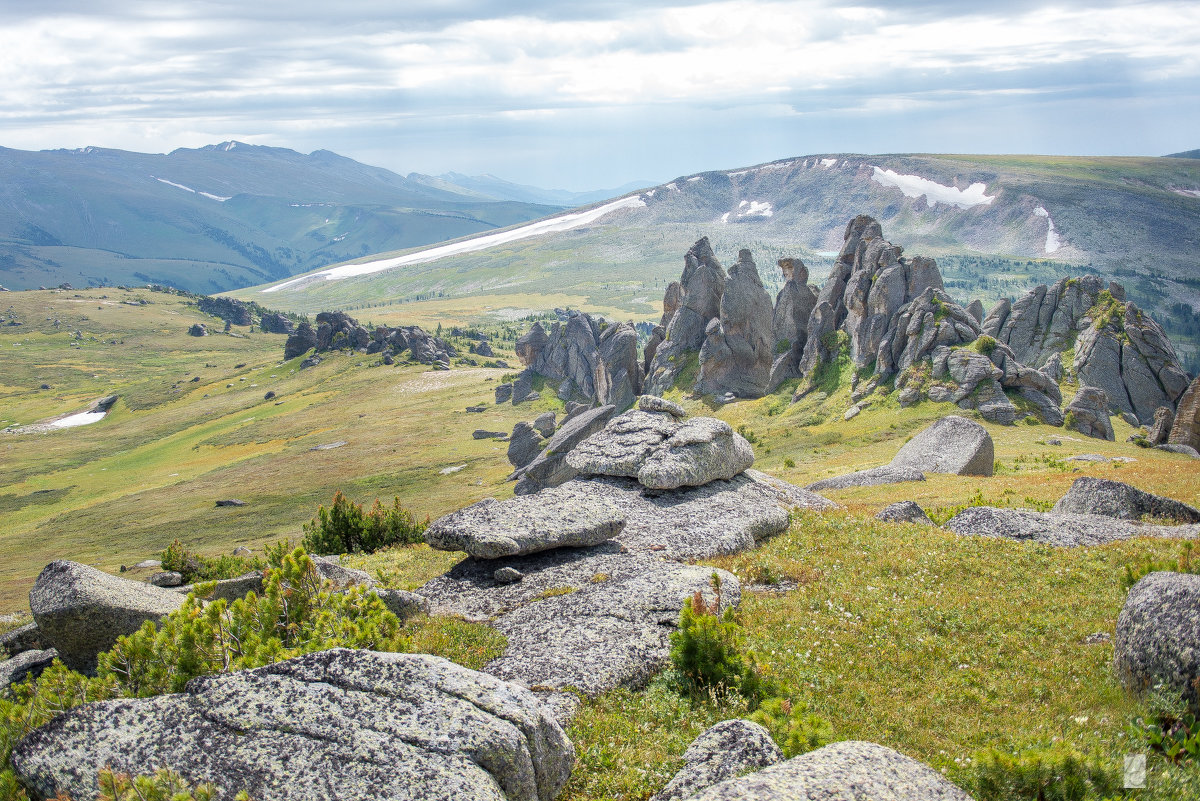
{"left": 689, "top": 740, "right": 971, "bottom": 801}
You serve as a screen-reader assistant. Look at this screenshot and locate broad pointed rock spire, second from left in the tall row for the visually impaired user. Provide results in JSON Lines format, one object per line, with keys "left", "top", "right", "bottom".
{"left": 696, "top": 249, "right": 775, "bottom": 398}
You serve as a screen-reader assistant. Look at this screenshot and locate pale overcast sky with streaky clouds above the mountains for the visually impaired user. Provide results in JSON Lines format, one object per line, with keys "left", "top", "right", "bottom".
{"left": 0, "top": 0, "right": 1200, "bottom": 189}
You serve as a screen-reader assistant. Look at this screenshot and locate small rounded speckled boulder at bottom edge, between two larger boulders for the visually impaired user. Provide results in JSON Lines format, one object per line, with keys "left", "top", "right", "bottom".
{"left": 650, "top": 719, "right": 784, "bottom": 801}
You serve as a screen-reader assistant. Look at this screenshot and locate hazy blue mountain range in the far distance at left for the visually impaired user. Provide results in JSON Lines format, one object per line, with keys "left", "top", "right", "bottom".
{"left": 0, "top": 141, "right": 556, "bottom": 293}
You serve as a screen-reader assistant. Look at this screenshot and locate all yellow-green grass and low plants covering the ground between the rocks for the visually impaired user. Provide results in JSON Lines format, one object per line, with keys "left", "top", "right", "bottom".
{"left": 0, "top": 289, "right": 1200, "bottom": 801}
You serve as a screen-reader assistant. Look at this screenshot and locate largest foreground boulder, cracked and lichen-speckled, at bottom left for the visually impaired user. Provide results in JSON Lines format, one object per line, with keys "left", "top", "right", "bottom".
{"left": 12, "top": 649, "right": 575, "bottom": 801}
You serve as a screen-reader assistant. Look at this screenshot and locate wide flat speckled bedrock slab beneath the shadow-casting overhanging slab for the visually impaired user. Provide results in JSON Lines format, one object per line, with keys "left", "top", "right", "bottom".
{"left": 418, "top": 543, "right": 740, "bottom": 695}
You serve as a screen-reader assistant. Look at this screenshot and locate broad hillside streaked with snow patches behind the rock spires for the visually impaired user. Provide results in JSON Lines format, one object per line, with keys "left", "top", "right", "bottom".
{"left": 238, "top": 153, "right": 1200, "bottom": 369}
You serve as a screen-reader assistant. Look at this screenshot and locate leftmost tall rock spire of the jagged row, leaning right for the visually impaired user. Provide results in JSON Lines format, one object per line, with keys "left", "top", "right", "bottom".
{"left": 646, "top": 236, "right": 726, "bottom": 395}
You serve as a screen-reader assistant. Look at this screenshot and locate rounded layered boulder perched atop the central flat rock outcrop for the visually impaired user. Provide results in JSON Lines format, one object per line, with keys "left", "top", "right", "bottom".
{"left": 566, "top": 409, "right": 754, "bottom": 489}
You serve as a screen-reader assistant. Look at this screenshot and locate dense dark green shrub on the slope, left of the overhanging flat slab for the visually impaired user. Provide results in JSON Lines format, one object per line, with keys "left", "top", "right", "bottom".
{"left": 304, "top": 492, "right": 430, "bottom": 554}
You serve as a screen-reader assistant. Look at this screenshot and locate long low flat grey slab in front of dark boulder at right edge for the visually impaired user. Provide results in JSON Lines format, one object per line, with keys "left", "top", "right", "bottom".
{"left": 944, "top": 506, "right": 1200, "bottom": 548}
